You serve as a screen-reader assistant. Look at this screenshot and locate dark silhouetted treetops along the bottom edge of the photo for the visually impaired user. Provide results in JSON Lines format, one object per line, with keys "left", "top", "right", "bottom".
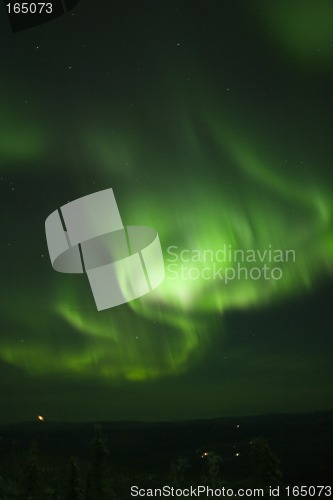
{"left": 0, "top": 426, "right": 283, "bottom": 500}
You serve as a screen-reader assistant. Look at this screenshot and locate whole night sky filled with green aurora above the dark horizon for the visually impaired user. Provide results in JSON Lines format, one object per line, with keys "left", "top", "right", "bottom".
{"left": 0, "top": 0, "right": 333, "bottom": 422}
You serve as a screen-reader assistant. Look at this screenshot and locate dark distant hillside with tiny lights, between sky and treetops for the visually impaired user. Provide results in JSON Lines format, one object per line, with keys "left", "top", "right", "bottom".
{"left": 0, "top": 412, "right": 333, "bottom": 492}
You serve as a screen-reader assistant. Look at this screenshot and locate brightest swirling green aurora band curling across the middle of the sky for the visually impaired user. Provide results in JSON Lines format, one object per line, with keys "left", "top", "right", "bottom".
{"left": 0, "top": 116, "right": 333, "bottom": 380}
